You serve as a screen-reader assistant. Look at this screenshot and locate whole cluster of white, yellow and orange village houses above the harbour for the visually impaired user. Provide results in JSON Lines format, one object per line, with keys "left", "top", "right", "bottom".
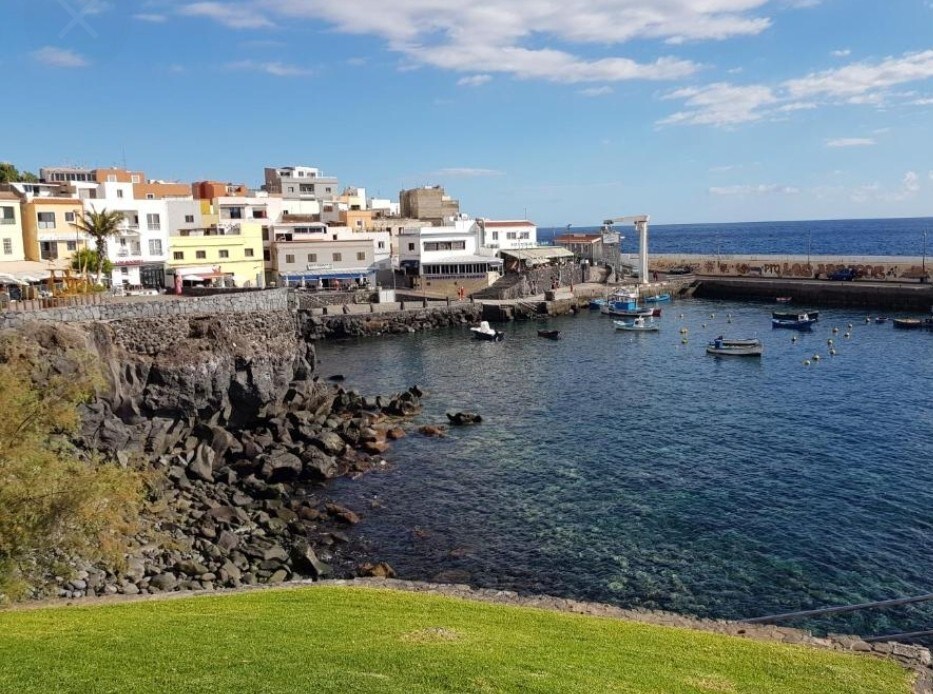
{"left": 0, "top": 166, "right": 568, "bottom": 296}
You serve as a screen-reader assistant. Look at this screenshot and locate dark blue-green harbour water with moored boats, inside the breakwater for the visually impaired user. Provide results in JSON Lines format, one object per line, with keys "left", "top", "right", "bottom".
{"left": 318, "top": 301, "right": 933, "bottom": 633}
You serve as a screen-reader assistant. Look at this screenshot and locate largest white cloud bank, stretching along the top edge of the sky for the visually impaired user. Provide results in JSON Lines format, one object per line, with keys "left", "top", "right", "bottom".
{"left": 175, "top": 0, "right": 792, "bottom": 83}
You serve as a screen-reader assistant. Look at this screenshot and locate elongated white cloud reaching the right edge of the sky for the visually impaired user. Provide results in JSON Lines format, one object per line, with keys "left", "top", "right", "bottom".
{"left": 659, "top": 50, "right": 933, "bottom": 127}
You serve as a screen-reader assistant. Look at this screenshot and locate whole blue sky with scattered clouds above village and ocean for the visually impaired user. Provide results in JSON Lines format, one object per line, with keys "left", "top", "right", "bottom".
{"left": 0, "top": 0, "right": 933, "bottom": 226}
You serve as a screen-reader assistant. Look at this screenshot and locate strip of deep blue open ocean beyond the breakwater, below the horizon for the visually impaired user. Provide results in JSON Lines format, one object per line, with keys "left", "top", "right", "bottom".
{"left": 538, "top": 217, "right": 933, "bottom": 257}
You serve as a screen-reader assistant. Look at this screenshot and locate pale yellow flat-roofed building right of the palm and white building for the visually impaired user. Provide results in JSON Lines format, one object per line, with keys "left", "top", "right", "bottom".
{"left": 165, "top": 222, "right": 264, "bottom": 287}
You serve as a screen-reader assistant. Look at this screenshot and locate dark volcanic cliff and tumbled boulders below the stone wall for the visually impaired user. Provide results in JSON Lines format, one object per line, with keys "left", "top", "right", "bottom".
{"left": 3, "top": 311, "right": 421, "bottom": 597}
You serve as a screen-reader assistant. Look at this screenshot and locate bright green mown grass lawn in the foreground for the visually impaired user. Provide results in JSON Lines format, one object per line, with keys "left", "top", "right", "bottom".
{"left": 0, "top": 587, "right": 912, "bottom": 694}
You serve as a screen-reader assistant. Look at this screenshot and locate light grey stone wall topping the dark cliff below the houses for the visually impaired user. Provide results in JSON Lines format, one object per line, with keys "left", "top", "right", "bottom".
{"left": 0, "top": 288, "right": 294, "bottom": 329}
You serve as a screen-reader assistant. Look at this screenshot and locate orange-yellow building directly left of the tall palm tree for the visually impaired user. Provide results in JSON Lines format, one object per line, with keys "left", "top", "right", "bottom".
{"left": 21, "top": 197, "right": 87, "bottom": 269}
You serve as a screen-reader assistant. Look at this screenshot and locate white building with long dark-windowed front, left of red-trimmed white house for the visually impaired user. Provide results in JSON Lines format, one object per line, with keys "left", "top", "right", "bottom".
{"left": 398, "top": 219, "right": 502, "bottom": 279}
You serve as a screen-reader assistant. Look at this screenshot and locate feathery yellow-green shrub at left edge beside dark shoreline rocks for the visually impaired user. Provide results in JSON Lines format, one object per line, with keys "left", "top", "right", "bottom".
{"left": 0, "top": 334, "right": 142, "bottom": 603}
